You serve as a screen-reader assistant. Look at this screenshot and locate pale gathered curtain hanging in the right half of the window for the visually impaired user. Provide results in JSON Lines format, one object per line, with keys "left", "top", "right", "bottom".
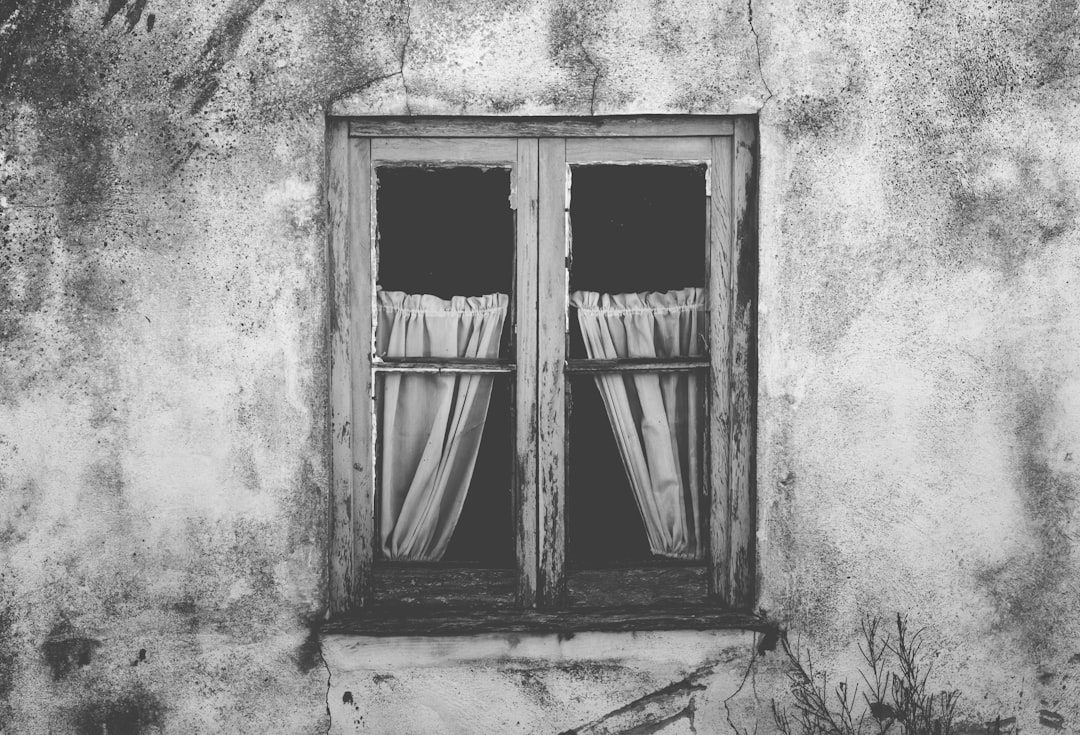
{"left": 570, "top": 288, "right": 705, "bottom": 558}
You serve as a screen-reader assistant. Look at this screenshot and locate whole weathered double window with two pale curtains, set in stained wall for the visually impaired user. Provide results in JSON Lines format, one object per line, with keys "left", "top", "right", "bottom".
{"left": 327, "top": 117, "right": 757, "bottom": 632}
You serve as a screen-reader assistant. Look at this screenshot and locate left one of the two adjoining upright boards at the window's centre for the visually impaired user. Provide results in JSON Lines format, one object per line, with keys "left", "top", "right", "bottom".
{"left": 514, "top": 138, "right": 539, "bottom": 608}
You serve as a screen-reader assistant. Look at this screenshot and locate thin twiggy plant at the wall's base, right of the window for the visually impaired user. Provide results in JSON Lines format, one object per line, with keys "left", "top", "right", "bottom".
{"left": 772, "top": 615, "right": 1005, "bottom": 735}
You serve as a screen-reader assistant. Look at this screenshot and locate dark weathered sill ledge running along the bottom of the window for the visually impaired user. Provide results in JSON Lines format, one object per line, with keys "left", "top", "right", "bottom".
{"left": 321, "top": 604, "right": 775, "bottom": 636}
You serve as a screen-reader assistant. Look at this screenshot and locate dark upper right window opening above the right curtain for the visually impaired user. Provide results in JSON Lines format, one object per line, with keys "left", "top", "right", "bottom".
{"left": 568, "top": 164, "right": 706, "bottom": 358}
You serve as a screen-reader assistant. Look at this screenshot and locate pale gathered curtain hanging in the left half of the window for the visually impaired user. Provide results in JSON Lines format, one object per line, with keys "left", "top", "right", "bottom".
{"left": 376, "top": 290, "right": 510, "bottom": 561}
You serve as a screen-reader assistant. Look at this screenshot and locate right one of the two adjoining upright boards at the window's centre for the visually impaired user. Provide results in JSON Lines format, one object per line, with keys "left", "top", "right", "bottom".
{"left": 536, "top": 138, "right": 566, "bottom": 608}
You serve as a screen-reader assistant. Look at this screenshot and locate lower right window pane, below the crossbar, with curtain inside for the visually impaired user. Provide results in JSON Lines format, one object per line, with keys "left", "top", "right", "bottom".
{"left": 567, "top": 372, "right": 707, "bottom": 567}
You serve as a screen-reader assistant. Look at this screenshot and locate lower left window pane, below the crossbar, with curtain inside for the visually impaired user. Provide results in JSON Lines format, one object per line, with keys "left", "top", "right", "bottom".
{"left": 376, "top": 372, "right": 514, "bottom": 568}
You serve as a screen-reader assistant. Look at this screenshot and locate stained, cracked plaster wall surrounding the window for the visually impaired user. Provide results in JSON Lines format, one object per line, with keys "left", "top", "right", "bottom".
{"left": 0, "top": 0, "right": 1080, "bottom": 735}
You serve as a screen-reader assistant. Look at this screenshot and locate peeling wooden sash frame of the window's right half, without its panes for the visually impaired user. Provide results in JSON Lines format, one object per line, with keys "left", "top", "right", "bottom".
{"left": 538, "top": 135, "right": 734, "bottom": 609}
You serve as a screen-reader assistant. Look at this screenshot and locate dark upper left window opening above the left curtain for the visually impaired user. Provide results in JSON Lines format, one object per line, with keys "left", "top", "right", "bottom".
{"left": 376, "top": 166, "right": 514, "bottom": 357}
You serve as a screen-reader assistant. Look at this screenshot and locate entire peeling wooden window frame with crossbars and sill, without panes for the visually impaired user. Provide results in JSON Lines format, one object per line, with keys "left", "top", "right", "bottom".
{"left": 327, "top": 115, "right": 760, "bottom": 635}
